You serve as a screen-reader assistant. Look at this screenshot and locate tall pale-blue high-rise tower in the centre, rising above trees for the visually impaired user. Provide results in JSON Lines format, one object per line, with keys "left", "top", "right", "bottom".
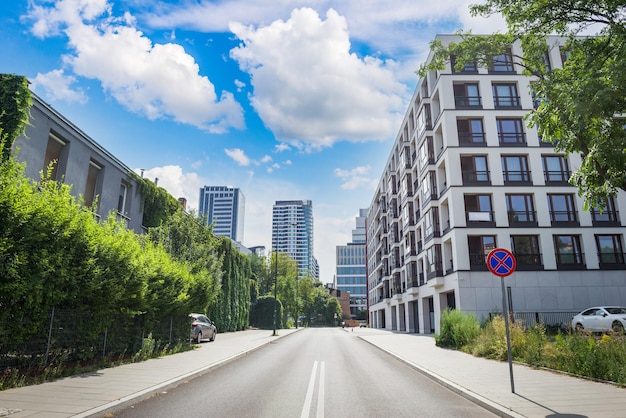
{"left": 272, "top": 200, "right": 319, "bottom": 278}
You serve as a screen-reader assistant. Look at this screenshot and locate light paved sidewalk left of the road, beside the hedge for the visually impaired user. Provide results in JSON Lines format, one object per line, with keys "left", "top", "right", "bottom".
{"left": 0, "top": 329, "right": 296, "bottom": 418}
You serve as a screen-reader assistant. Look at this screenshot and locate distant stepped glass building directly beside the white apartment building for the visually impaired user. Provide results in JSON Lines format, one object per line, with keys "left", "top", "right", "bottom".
{"left": 334, "top": 209, "right": 367, "bottom": 319}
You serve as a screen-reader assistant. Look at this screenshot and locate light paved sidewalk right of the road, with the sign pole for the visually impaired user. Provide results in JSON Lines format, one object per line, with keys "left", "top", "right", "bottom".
{"left": 351, "top": 328, "right": 626, "bottom": 418}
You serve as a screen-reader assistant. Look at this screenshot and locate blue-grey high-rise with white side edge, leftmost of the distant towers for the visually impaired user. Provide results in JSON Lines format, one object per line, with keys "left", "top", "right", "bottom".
{"left": 199, "top": 186, "right": 246, "bottom": 242}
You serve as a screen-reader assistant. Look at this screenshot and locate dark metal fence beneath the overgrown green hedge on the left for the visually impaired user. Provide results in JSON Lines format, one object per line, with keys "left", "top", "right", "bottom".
{"left": 0, "top": 309, "right": 190, "bottom": 372}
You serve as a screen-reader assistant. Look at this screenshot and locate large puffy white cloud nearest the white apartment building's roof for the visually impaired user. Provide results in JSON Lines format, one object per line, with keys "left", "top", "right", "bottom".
{"left": 231, "top": 8, "right": 407, "bottom": 150}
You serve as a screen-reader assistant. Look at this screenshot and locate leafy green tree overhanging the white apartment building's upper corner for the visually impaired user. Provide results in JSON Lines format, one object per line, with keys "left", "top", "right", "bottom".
{"left": 419, "top": 0, "right": 626, "bottom": 208}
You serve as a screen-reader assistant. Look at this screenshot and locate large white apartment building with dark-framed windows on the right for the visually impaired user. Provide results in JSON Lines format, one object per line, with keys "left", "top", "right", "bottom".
{"left": 367, "top": 35, "right": 626, "bottom": 333}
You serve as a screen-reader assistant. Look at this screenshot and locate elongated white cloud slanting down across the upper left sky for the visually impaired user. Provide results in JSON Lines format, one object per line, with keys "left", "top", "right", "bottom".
{"left": 28, "top": 0, "right": 244, "bottom": 133}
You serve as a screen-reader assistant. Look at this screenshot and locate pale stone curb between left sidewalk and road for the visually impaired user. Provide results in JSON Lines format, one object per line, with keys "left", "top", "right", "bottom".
{"left": 74, "top": 329, "right": 300, "bottom": 418}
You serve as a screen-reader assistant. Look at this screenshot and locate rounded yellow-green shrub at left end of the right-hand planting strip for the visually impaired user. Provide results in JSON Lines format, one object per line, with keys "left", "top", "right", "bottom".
{"left": 435, "top": 309, "right": 480, "bottom": 349}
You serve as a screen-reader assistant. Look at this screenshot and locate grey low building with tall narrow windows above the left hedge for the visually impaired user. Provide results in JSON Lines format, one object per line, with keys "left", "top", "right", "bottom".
{"left": 12, "top": 93, "right": 144, "bottom": 234}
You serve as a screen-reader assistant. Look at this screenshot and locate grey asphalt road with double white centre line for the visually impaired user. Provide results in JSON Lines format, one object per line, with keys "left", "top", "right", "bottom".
{"left": 107, "top": 328, "right": 495, "bottom": 418}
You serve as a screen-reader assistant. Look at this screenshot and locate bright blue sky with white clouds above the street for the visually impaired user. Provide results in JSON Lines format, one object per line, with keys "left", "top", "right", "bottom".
{"left": 0, "top": 0, "right": 505, "bottom": 283}
